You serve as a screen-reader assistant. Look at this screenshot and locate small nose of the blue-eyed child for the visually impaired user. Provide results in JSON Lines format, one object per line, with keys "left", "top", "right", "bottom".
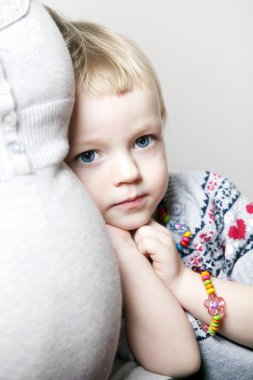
{"left": 112, "top": 154, "right": 141, "bottom": 186}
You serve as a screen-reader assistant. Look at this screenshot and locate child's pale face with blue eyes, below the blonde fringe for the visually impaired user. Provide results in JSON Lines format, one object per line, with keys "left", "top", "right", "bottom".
{"left": 66, "top": 88, "right": 168, "bottom": 230}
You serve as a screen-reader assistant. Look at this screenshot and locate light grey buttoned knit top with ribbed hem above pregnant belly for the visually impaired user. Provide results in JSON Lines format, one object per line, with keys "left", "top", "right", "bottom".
{"left": 0, "top": 0, "right": 75, "bottom": 181}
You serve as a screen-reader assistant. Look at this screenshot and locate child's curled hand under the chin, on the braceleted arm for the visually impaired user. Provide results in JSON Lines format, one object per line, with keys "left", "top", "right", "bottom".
{"left": 134, "top": 219, "right": 185, "bottom": 290}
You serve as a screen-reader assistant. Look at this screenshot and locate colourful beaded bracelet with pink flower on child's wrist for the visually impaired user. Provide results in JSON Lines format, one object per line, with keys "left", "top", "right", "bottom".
{"left": 200, "top": 271, "right": 225, "bottom": 335}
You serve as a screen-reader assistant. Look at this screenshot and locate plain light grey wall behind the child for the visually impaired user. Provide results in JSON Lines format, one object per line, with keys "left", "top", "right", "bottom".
{"left": 44, "top": 0, "right": 253, "bottom": 200}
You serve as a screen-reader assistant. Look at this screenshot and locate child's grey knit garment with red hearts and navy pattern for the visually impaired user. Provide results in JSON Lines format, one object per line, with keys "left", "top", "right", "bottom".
{"left": 116, "top": 171, "right": 253, "bottom": 380}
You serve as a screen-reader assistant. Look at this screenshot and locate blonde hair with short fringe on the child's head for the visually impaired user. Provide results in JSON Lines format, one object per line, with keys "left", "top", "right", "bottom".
{"left": 46, "top": 7, "right": 166, "bottom": 119}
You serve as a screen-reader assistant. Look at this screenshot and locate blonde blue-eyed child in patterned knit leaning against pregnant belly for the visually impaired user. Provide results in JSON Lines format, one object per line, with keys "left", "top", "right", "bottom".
{"left": 47, "top": 6, "right": 253, "bottom": 380}
